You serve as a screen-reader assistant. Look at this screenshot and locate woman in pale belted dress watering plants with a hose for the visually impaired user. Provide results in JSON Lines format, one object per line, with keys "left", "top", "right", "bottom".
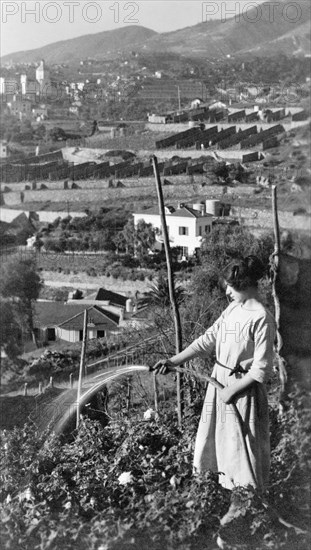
{"left": 154, "top": 256, "right": 275, "bottom": 492}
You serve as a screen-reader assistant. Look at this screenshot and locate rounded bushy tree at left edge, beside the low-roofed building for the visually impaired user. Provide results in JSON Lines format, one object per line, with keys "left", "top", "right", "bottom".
{"left": 0, "top": 256, "right": 41, "bottom": 341}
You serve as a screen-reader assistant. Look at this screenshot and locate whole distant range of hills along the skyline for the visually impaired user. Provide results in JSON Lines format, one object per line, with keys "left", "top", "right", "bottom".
{"left": 2, "top": 0, "right": 311, "bottom": 63}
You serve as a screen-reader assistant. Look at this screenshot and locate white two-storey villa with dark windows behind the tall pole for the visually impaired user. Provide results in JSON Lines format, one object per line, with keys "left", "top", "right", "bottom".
{"left": 133, "top": 202, "right": 213, "bottom": 258}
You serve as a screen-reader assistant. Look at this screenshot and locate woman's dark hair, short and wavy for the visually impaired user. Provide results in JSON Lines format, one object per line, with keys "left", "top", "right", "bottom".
{"left": 223, "top": 256, "right": 265, "bottom": 291}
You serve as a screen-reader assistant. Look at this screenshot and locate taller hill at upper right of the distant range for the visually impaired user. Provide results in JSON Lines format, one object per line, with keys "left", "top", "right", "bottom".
{"left": 147, "top": 0, "right": 311, "bottom": 58}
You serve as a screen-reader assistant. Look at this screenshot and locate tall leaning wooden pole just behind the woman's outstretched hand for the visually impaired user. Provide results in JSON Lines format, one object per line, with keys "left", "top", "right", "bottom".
{"left": 152, "top": 156, "right": 184, "bottom": 426}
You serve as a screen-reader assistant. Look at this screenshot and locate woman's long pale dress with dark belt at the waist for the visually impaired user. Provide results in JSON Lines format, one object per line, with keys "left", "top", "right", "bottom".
{"left": 190, "top": 300, "right": 275, "bottom": 491}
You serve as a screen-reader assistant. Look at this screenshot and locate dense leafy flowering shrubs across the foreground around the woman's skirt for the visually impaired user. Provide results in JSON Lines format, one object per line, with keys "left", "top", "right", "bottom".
{"left": 0, "top": 402, "right": 307, "bottom": 550}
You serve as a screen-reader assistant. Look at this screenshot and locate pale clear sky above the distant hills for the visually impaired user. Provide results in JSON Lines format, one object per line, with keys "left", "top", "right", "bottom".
{"left": 0, "top": 0, "right": 262, "bottom": 56}
